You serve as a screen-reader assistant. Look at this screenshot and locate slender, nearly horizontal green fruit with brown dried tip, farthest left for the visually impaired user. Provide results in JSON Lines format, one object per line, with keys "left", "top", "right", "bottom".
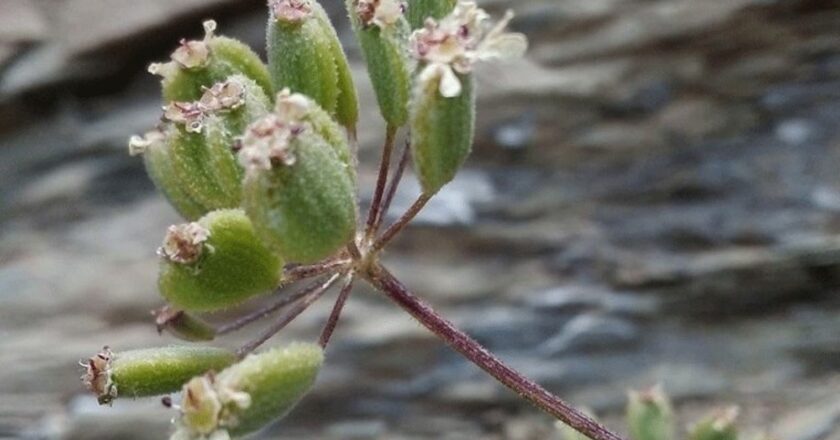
{"left": 82, "top": 346, "right": 236, "bottom": 404}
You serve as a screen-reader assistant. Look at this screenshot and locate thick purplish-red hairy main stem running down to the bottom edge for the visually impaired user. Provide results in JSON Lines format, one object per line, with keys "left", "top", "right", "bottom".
{"left": 366, "top": 264, "right": 622, "bottom": 440}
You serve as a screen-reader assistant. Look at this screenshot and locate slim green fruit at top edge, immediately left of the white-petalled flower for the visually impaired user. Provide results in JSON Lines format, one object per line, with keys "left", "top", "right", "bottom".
{"left": 346, "top": 0, "right": 414, "bottom": 129}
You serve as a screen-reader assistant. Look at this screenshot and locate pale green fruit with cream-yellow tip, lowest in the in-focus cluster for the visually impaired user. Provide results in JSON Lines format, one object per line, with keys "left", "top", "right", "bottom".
{"left": 172, "top": 344, "right": 324, "bottom": 440}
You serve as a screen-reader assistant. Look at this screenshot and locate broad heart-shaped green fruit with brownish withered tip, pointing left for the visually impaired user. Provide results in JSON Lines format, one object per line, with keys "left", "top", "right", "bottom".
{"left": 158, "top": 209, "right": 283, "bottom": 311}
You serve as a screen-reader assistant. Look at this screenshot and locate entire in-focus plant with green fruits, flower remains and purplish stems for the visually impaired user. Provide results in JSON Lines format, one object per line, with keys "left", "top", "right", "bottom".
{"left": 83, "top": 0, "right": 619, "bottom": 440}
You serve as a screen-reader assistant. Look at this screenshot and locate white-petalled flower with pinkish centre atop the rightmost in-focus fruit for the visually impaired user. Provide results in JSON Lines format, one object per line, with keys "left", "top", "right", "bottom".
{"left": 411, "top": 1, "right": 528, "bottom": 98}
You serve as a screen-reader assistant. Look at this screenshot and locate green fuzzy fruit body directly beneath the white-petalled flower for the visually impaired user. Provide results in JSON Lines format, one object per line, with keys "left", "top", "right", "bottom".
{"left": 410, "top": 74, "right": 475, "bottom": 195}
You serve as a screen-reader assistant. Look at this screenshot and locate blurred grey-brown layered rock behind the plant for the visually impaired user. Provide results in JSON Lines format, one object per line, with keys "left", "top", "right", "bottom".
{"left": 0, "top": 0, "right": 840, "bottom": 440}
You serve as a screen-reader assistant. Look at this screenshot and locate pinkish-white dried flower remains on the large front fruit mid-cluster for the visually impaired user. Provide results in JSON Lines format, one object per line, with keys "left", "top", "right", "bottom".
{"left": 238, "top": 89, "right": 310, "bottom": 170}
